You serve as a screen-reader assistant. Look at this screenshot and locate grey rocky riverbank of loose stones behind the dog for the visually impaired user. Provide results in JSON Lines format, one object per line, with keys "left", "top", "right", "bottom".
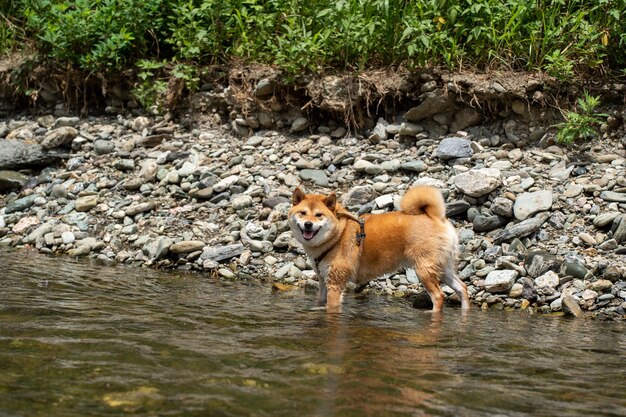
{"left": 0, "top": 106, "right": 626, "bottom": 319}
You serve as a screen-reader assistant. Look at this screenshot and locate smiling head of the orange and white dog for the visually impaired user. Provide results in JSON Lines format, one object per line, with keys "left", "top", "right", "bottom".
{"left": 289, "top": 188, "right": 337, "bottom": 247}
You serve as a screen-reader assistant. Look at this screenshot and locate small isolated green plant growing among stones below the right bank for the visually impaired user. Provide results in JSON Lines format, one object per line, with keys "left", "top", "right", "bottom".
{"left": 555, "top": 91, "right": 607, "bottom": 145}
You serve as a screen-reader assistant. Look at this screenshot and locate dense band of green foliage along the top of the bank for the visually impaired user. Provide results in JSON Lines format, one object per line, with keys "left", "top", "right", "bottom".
{"left": 0, "top": 0, "right": 626, "bottom": 108}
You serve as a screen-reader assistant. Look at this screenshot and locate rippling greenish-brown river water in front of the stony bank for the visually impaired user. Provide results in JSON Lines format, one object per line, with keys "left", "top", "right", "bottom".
{"left": 0, "top": 251, "right": 626, "bottom": 417}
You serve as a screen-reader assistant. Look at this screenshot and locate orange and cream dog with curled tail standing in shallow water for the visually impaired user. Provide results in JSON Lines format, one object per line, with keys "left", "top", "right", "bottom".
{"left": 288, "top": 186, "right": 470, "bottom": 312}
